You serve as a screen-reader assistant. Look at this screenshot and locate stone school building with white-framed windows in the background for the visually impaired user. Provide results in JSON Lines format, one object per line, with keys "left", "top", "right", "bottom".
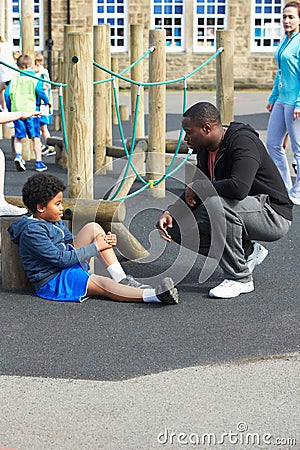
{"left": 1, "top": 0, "right": 286, "bottom": 89}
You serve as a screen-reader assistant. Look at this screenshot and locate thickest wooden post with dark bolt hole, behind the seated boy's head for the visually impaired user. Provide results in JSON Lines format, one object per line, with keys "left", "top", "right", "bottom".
{"left": 67, "top": 32, "right": 93, "bottom": 198}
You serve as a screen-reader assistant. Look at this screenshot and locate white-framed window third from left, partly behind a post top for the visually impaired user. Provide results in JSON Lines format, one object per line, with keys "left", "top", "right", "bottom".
{"left": 151, "top": 0, "right": 184, "bottom": 52}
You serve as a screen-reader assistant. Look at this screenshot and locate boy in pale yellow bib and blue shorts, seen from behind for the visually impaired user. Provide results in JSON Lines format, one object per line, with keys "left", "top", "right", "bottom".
{"left": 5, "top": 55, "right": 49, "bottom": 172}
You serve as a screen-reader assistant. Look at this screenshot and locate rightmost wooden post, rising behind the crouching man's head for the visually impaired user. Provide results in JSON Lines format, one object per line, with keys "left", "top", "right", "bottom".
{"left": 216, "top": 30, "right": 234, "bottom": 125}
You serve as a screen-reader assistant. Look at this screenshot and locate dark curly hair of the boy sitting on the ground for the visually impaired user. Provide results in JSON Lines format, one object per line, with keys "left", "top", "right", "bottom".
{"left": 22, "top": 173, "right": 66, "bottom": 213}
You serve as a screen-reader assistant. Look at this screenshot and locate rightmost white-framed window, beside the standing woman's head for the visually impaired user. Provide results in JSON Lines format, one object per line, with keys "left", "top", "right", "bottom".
{"left": 251, "top": 0, "right": 286, "bottom": 52}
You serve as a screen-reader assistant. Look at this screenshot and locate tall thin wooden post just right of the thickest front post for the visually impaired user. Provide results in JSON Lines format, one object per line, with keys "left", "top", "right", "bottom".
{"left": 94, "top": 25, "right": 109, "bottom": 175}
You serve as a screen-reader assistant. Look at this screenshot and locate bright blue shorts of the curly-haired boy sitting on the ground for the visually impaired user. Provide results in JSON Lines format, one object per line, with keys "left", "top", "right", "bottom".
{"left": 36, "top": 262, "right": 91, "bottom": 302}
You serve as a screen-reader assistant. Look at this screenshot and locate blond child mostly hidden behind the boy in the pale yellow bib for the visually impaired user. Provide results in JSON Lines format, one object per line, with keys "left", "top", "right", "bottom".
{"left": 34, "top": 53, "right": 56, "bottom": 156}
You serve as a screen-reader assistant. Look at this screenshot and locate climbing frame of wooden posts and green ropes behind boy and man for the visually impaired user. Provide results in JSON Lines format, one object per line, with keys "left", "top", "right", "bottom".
{"left": 0, "top": 14, "right": 233, "bottom": 288}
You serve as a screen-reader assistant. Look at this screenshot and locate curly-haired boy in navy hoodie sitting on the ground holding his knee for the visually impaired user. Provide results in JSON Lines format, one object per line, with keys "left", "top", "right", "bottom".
{"left": 8, "top": 173, "right": 178, "bottom": 304}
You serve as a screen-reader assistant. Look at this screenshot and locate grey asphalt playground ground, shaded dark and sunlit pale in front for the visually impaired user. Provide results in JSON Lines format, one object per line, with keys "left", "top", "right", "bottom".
{"left": 0, "top": 92, "right": 300, "bottom": 450}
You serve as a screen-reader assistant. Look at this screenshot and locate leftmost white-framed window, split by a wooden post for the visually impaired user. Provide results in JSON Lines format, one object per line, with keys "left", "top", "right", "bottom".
{"left": 8, "top": 0, "right": 44, "bottom": 51}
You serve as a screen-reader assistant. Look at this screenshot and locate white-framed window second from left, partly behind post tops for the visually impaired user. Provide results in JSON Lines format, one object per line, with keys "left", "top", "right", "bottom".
{"left": 94, "top": 0, "right": 128, "bottom": 53}
